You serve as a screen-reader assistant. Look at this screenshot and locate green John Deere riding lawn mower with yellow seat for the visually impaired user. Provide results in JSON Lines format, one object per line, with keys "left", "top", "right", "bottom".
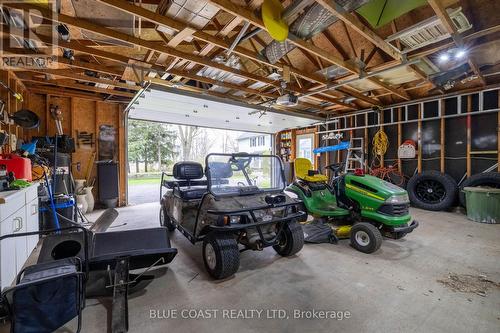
{"left": 287, "top": 158, "right": 418, "bottom": 253}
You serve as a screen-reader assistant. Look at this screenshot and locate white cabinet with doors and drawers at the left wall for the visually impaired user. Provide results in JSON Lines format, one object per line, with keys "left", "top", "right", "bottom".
{"left": 0, "top": 185, "right": 38, "bottom": 289}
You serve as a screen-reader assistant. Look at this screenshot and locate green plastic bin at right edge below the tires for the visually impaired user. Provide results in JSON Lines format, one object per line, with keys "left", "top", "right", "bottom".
{"left": 463, "top": 187, "right": 500, "bottom": 223}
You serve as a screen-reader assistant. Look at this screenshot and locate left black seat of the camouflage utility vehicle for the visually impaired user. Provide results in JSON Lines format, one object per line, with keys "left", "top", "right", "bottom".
{"left": 173, "top": 162, "right": 207, "bottom": 200}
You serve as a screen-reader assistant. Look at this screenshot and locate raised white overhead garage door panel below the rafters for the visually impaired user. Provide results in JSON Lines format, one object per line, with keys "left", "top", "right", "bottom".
{"left": 127, "top": 86, "right": 321, "bottom": 134}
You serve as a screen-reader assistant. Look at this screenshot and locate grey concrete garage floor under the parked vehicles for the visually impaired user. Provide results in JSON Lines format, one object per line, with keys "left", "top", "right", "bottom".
{"left": 9, "top": 203, "right": 500, "bottom": 333}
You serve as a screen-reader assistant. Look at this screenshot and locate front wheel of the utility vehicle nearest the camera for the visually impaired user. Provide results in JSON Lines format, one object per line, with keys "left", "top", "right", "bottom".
{"left": 203, "top": 232, "right": 240, "bottom": 279}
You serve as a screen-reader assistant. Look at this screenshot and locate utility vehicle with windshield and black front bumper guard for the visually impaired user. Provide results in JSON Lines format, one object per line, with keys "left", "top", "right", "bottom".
{"left": 160, "top": 153, "right": 306, "bottom": 279}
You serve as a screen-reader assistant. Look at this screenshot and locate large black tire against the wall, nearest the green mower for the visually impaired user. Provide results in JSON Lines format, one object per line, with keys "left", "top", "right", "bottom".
{"left": 406, "top": 170, "right": 458, "bottom": 211}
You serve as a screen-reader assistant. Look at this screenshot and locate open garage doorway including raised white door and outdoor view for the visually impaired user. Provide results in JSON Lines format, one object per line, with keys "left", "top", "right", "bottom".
{"left": 127, "top": 86, "right": 319, "bottom": 204}
